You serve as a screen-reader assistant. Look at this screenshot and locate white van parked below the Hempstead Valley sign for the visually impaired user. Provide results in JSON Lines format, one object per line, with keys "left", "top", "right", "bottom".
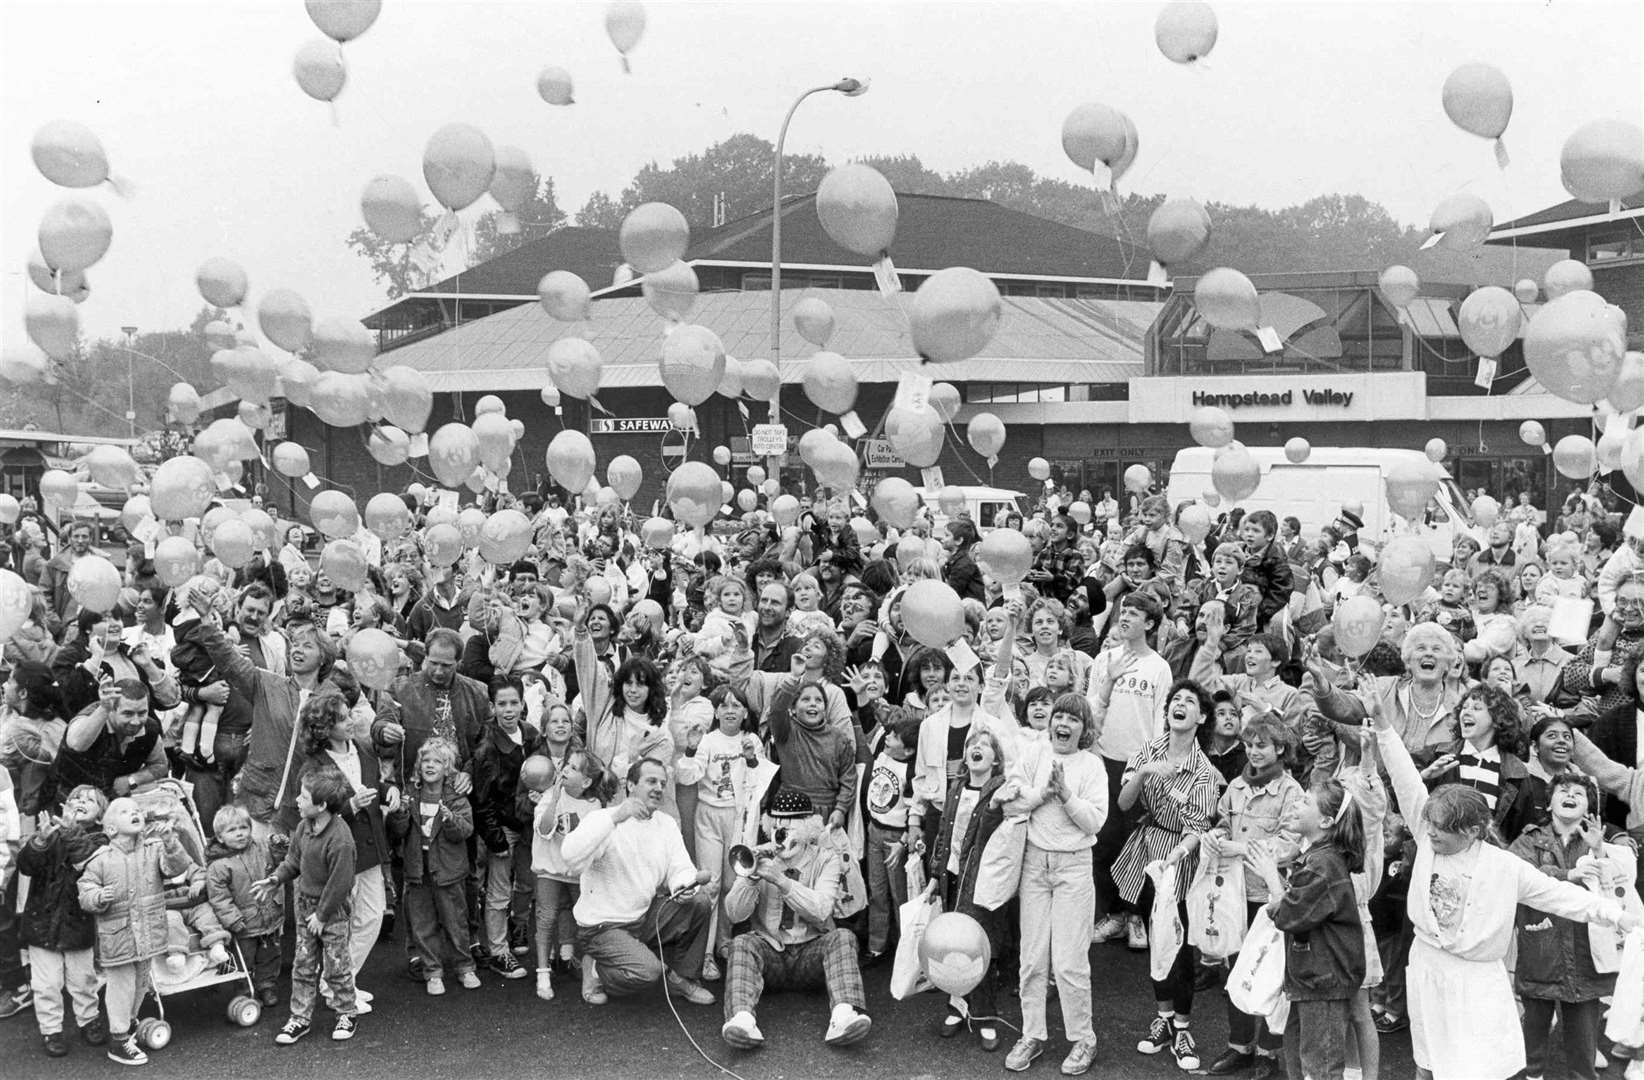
{"left": 1167, "top": 445, "right": 1478, "bottom": 559}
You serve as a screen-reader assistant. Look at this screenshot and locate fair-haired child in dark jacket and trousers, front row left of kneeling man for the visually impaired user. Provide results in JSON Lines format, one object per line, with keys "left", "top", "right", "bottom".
{"left": 387, "top": 736, "right": 480, "bottom": 996}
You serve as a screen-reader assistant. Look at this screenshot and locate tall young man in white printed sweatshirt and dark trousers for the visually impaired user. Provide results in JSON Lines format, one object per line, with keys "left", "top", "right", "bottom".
{"left": 1085, "top": 592, "right": 1174, "bottom": 950}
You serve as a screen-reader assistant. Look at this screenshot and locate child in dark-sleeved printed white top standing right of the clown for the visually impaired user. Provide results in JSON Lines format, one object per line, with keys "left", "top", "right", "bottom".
{"left": 863, "top": 708, "right": 922, "bottom": 965}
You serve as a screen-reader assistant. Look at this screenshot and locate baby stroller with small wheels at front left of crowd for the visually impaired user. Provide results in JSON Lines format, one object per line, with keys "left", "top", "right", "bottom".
{"left": 132, "top": 779, "right": 263, "bottom": 1050}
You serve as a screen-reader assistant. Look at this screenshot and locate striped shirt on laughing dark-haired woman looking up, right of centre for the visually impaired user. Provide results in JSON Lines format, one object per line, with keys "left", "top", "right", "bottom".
{"left": 1113, "top": 735, "right": 1221, "bottom": 904}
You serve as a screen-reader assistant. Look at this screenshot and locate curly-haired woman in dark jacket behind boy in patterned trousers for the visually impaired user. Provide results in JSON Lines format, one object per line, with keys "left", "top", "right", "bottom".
{"left": 293, "top": 681, "right": 399, "bottom": 1013}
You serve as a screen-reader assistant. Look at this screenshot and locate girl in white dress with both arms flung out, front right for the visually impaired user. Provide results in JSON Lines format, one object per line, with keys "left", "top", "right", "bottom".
{"left": 1373, "top": 708, "right": 1639, "bottom": 1080}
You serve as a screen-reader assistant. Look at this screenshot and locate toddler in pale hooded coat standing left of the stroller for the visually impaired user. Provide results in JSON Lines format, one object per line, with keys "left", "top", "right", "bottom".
{"left": 79, "top": 799, "right": 192, "bottom": 1065}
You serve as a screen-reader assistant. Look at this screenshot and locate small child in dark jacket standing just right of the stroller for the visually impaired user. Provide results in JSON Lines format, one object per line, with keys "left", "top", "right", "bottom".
{"left": 206, "top": 802, "right": 284, "bottom": 1009}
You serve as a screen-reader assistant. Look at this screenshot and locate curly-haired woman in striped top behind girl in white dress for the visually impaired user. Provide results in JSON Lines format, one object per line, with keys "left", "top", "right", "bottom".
{"left": 1422, "top": 682, "right": 1531, "bottom": 843}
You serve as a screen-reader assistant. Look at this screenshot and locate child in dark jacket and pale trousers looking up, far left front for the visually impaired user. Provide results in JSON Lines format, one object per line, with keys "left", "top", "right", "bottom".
{"left": 16, "top": 784, "right": 109, "bottom": 1057}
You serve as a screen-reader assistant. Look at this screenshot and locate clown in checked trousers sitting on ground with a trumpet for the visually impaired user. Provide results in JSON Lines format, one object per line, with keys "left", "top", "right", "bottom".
{"left": 720, "top": 789, "right": 873, "bottom": 1050}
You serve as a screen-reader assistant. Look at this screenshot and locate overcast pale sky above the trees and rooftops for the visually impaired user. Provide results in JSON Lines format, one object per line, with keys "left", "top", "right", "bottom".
{"left": 0, "top": 0, "right": 1644, "bottom": 351}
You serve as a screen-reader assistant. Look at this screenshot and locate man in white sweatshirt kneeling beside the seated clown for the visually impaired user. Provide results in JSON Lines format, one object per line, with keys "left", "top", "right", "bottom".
{"left": 561, "top": 758, "right": 713, "bottom": 1004}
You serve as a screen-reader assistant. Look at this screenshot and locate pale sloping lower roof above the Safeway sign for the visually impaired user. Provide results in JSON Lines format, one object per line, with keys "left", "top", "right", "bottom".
{"left": 391, "top": 289, "right": 1161, "bottom": 391}
